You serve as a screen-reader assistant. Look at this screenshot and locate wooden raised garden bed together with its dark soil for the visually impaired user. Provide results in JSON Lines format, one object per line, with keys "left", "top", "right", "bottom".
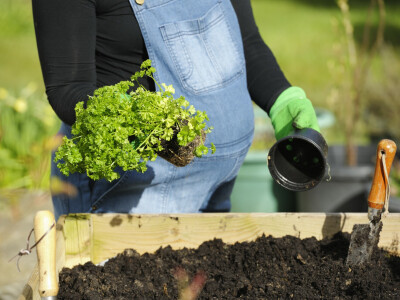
{"left": 20, "top": 213, "right": 400, "bottom": 299}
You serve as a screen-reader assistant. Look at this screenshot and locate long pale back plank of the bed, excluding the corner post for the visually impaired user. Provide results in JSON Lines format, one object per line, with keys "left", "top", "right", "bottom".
{"left": 91, "top": 213, "right": 400, "bottom": 263}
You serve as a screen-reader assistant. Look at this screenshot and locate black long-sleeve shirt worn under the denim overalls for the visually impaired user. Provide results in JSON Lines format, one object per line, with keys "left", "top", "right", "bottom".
{"left": 32, "top": 0, "right": 290, "bottom": 125}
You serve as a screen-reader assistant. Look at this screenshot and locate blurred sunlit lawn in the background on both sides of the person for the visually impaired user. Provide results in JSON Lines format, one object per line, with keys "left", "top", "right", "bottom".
{"left": 0, "top": 0, "right": 400, "bottom": 102}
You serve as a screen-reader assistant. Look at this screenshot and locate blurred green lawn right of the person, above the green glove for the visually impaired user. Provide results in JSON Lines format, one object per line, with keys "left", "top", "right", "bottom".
{"left": 252, "top": 0, "right": 400, "bottom": 107}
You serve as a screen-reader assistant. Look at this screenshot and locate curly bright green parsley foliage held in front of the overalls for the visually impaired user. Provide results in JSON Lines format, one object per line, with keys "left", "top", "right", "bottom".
{"left": 54, "top": 60, "right": 215, "bottom": 181}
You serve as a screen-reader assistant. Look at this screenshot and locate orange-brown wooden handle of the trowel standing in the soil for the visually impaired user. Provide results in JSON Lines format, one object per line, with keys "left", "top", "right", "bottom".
{"left": 368, "top": 140, "right": 397, "bottom": 210}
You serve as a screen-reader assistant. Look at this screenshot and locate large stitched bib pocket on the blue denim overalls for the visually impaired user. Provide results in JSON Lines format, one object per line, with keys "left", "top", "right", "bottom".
{"left": 160, "top": 3, "right": 245, "bottom": 94}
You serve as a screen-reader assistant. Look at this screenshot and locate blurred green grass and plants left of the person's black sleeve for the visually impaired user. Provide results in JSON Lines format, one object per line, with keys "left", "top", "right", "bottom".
{"left": 0, "top": 0, "right": 59, "bottom": 190}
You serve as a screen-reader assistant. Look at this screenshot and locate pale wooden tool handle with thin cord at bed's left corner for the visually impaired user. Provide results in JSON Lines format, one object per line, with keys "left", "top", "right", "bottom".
{"left": 34, "top": 210, "right": 58, "bottom": 297}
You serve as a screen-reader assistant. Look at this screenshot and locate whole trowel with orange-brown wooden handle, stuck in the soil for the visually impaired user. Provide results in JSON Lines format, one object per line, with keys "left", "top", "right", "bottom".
{"left": 346, "top": 139, "right": 397, "bottom": 266}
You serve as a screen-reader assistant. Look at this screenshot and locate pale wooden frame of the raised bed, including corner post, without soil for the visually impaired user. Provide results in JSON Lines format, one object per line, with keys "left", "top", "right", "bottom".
{"left": 19, "top": 213, "right": 400, "bottom": 300}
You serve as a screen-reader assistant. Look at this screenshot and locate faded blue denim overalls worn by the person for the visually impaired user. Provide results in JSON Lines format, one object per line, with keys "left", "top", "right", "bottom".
{"left": 52, "top": 0, "right": 254, "bottom": 218}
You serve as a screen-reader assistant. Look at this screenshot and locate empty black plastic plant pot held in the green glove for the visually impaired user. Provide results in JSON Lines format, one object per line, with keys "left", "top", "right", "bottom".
{"left": 268, "top": 128, "right": 328, "bottom": 192}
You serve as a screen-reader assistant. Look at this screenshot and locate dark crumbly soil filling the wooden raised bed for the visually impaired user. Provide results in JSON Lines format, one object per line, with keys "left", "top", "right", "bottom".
{"left": 58, "top": 233, "right": 400, "bottom": 300}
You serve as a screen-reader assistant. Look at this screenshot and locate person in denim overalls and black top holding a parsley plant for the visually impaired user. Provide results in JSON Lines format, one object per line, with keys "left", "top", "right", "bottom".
{"left": 32, "top": 0, "right": 319, "bottom": 219}
